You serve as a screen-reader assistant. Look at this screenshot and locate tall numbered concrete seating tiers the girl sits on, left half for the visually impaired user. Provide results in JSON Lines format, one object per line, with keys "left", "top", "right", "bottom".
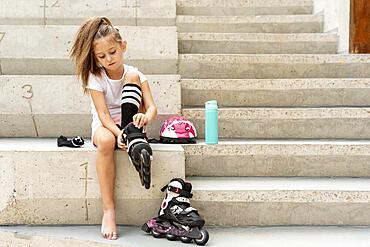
{"left": 0, "top": 0, "right": 185, "bottom": 226}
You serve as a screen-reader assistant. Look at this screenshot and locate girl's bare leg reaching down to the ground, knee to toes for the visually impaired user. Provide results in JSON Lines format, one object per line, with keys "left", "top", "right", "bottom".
{"left": 93, "top": 127, "right": 118, "bottom": 240}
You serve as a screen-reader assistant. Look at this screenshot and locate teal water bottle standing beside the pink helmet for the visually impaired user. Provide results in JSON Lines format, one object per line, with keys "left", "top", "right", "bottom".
{"left": 204, "top": 100, "right": 218, "bottom": 144}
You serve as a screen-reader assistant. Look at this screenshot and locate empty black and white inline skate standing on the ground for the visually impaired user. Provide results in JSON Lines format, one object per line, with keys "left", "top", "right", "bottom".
{"left": 141, "top": 178, "right": 209, "bottom": 245}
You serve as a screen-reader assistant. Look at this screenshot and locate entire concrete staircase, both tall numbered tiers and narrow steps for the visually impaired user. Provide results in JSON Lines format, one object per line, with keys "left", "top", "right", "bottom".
{"left": 0, "top": 0, "right": 370, "bottom": 247}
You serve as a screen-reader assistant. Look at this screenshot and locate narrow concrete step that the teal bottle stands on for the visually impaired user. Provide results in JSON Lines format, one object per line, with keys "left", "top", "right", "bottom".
{"left": 183, "top": 140, "right": 370, "bottom": 177}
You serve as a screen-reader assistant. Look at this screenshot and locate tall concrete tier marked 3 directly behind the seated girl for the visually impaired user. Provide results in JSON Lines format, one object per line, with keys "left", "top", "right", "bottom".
{"left": 0, "top": 75, "right": 181, "bottom": 137}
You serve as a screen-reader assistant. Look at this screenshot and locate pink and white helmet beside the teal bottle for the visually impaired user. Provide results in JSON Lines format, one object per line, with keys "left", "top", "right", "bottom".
{"left": 159, "top": 116, "right": 197, "bottom": 143}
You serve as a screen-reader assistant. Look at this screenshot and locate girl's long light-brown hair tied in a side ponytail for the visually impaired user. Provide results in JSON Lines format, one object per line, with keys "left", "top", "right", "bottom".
{"left": 69, "top": 17, "right": 122, "bottom": 94}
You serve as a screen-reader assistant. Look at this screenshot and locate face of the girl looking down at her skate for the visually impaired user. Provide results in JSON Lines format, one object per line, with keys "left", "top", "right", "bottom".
{"left": 94, "top": 36, "right": 127, "bottom": 71}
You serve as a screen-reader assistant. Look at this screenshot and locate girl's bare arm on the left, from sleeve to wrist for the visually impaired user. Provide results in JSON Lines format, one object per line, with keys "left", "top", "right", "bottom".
{"left": 89, "top": 89, "right": 121, "bottom": 137}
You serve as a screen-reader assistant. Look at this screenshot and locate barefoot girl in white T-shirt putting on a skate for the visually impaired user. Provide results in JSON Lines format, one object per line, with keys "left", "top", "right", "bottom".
{"left": 70, "top": 17, "right": 157, "bottom": 240}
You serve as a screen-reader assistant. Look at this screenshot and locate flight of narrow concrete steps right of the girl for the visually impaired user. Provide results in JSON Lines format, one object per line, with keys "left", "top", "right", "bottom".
{"left": 177, "top": 0, "right": 370, "bottom": 226}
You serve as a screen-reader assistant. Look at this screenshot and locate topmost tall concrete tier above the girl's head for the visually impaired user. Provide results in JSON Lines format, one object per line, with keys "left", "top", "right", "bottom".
{"left": 0, "top": 0, "right": 176, "bottom": 26}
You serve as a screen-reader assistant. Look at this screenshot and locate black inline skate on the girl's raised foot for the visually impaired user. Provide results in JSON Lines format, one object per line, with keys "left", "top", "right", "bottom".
{"left": 122, "top": 123, "right": 153, "bottom": 189}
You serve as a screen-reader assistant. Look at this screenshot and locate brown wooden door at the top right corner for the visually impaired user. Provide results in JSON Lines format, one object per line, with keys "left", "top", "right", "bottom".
{"left": 349, "top": 0, "right": 370, "bottom": 53}
